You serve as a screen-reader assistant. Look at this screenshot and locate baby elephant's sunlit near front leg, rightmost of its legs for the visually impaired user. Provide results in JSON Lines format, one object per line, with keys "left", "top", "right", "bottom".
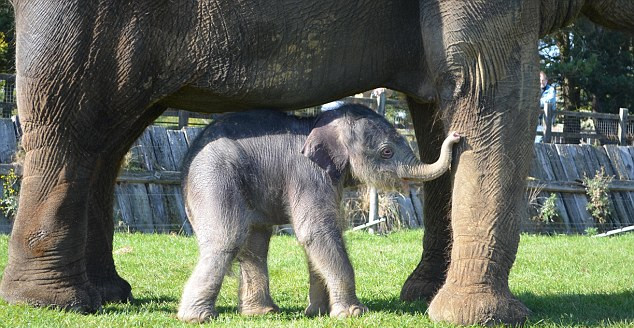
{"left": 294, "top": 212, "right": 368, "bottom": 317}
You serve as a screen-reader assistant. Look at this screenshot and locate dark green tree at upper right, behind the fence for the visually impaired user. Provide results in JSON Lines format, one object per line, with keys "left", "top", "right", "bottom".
{"left": 540, "top": 19, "right": 634, "bottom": 113}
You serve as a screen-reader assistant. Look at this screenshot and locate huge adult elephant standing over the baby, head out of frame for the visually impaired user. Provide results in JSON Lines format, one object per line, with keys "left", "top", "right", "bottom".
{"left": 0, "top": 0, "right": 634, "bottom": 324}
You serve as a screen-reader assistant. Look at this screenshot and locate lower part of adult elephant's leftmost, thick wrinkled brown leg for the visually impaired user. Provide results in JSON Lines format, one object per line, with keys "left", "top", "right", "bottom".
{"left": 0, "top": 129, "right": 101, "bottom": 312}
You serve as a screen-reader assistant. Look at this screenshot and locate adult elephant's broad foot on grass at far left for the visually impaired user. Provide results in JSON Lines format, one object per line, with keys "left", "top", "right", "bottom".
{"left": 0, "top": 267, "right": 102, "bottom": 313}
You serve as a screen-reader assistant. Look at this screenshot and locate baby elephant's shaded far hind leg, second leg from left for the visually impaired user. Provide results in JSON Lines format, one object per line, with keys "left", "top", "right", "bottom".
{"left": 238, "top": 227, "right": 279, "bottom": 315}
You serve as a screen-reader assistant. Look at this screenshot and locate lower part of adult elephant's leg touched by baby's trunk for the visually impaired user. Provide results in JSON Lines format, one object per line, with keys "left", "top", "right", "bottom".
{"left": 429, "top": 144, "right": 530, "bottom": 324}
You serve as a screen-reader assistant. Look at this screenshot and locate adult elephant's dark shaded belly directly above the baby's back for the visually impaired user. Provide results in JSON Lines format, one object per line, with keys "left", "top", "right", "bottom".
{"left": 160, "top": 49, "right": 382, "bottom": 112}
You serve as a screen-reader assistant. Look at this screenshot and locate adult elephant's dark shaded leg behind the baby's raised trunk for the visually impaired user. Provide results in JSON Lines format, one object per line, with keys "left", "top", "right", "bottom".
{"left": 401, "top": 99, "right": 451, "bottom": 301}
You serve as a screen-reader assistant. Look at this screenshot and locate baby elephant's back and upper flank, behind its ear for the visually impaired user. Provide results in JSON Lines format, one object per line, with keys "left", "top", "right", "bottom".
{"left": 183, "top": 110, "right": 312, "bottom": 220}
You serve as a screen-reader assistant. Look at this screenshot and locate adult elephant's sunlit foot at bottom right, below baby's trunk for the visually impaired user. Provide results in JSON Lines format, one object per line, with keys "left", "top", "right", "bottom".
{"left": 428, "top": 286, "right": 530, "bottom": 326}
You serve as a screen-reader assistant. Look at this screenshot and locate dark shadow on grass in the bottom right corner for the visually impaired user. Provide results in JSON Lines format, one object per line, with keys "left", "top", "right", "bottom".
{"left": 518, "top": 291, "right": 634, "bottom": 326}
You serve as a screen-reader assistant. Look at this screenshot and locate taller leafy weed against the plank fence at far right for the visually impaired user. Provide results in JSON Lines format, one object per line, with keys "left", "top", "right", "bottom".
{"left": 583, "top": 167, "right": 614, "bottom": 224}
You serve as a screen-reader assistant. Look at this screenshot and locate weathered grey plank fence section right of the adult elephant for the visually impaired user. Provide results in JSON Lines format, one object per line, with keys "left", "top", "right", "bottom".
{"left": 524, "top": 143, "right": 634, "bottom": 233}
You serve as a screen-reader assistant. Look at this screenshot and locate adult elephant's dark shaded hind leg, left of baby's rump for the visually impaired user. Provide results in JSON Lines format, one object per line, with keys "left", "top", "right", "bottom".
{"left": 86, "top": 106, "right": 164, "bottom": 303}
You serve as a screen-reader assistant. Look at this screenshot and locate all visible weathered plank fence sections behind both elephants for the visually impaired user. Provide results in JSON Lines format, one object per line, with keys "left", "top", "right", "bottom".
{"left": 0, "top": 114, "right": 634, "bottom": 234}
